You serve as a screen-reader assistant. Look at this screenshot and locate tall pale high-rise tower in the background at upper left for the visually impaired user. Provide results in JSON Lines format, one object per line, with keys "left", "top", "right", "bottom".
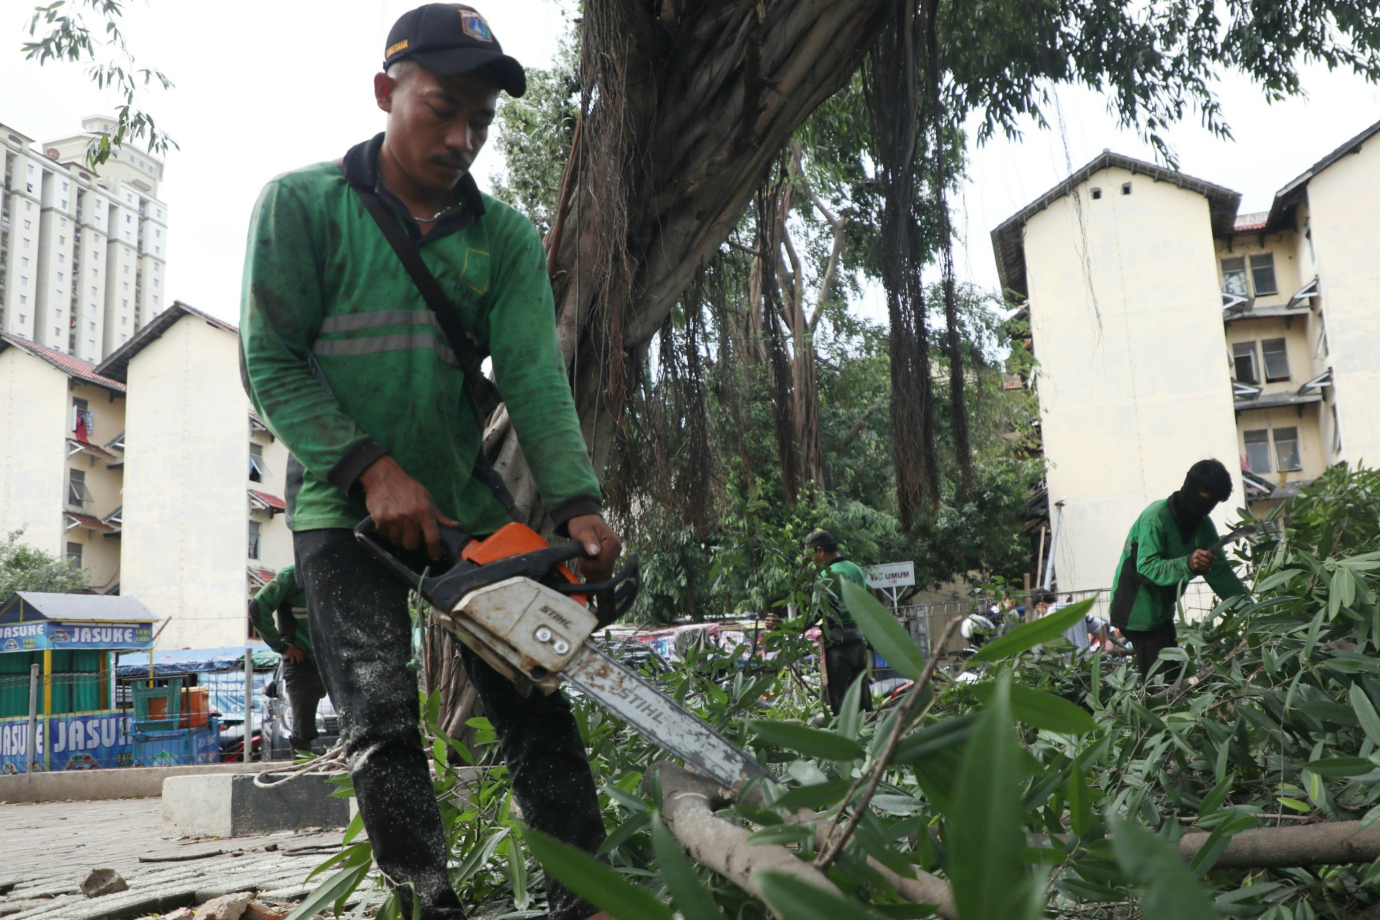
{"left": 0, "top": 116, "right": 167, "bottom": 363}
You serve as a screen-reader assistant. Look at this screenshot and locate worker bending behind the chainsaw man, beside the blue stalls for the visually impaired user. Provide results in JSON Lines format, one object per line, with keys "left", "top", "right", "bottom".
{"left": 250, "top": 566, "right": 326, "bottom": 752}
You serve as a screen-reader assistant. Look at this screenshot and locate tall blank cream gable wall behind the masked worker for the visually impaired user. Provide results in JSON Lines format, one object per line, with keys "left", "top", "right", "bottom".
{"left": 1025, "top": 168, "right": 1242, "bottom": 590}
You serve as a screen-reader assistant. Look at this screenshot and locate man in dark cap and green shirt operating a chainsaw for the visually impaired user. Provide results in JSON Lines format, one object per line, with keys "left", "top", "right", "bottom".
{"left": 240, "top": 4, "right": 621, "bottom": 920}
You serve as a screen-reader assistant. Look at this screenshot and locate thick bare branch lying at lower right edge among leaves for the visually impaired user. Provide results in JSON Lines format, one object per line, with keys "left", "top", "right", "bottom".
{"left": 1179, "top": 821, "right": 1380, "bottom": 869}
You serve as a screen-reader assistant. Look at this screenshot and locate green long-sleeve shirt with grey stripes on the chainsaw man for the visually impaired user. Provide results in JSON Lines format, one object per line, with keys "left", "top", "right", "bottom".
{"left": 240, "top": 135, "right": 599, "bottom": 534}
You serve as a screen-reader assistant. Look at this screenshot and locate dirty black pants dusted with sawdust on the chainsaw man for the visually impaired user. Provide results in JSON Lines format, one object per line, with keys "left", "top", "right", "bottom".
{"left": 293, "top": 530, "right": 604, "bottom": 920}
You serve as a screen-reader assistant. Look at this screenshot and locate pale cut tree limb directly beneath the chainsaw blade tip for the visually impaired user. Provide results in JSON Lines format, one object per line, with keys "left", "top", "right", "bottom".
{"left": 643, "top": 763, "right": 839, "bottom": 915}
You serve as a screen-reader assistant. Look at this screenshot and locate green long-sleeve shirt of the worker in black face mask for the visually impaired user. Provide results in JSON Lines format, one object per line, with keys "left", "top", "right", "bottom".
{"left": 1111, "top": 499, "right": 1246, "bottom": 629}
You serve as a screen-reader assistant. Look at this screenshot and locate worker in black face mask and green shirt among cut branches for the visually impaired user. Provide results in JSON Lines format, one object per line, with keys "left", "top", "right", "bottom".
{"left": 1111, "top": 459, "right": 1246, "bottom": 683}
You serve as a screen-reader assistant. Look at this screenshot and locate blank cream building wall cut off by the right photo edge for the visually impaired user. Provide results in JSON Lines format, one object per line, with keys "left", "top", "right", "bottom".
{"left": 1300, "top": 137, "right": 1380, "bottom": 466}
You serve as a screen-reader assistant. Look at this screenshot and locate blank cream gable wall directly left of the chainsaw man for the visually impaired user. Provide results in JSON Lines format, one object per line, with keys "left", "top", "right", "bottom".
{"left": 121, "top": 316, "right": 250, "bottom": 648}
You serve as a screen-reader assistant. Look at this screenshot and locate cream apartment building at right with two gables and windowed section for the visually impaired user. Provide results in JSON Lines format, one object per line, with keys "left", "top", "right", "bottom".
{"left": 992, "top": 123, "right": 1380, "bottom": 590}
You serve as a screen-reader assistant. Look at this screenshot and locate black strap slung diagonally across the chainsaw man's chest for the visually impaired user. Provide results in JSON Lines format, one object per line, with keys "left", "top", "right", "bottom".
{"left": 351, "top": 182, "right": 523, "bottom": 520}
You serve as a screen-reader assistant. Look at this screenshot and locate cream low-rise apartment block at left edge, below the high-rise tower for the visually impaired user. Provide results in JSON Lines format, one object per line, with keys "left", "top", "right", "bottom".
{"left": 0, "top": 334, "right": 126, "bottom": 593}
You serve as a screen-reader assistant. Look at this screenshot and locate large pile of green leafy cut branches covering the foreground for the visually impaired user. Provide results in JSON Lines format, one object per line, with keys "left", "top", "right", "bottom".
{"left": 302, "top": 469, "right": 1380, "bottom": 920}
